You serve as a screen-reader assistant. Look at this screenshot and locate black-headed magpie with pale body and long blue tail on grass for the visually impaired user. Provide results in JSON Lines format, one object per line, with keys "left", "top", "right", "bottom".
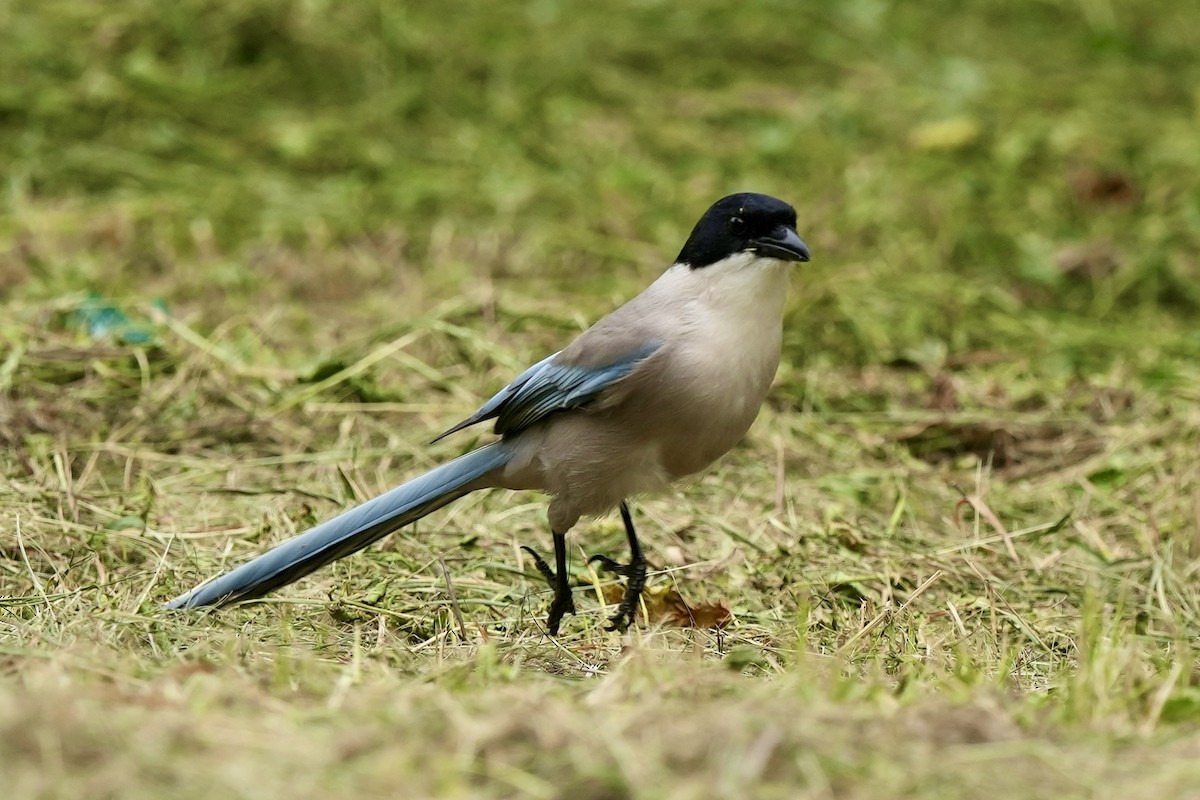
{"left": 166, "top": 192, "right": 810, "bottom": 636}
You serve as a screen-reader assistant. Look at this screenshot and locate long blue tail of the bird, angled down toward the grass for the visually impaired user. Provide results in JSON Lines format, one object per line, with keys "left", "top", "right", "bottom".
{"left": 167, "top": 443, "right": 512, "bottom": 608}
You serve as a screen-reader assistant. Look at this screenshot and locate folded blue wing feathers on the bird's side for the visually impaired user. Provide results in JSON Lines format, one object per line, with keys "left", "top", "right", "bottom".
{"left": 433, "top": 343, "right": 659, "bottom": 441}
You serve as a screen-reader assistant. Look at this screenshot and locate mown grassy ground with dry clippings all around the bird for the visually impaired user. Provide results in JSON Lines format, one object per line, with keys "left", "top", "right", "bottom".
{"left": 0, "top": 0, "right": 1200, "bottom": 798}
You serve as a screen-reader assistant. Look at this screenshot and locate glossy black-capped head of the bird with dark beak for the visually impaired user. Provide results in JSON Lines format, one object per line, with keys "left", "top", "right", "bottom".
{"left": 676, "top": 192, "right": 809, "bottom": 270}
